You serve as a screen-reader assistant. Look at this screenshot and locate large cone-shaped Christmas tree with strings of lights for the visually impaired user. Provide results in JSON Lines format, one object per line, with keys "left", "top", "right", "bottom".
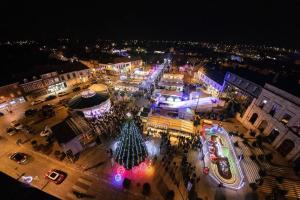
{"left": 115, "top": 115, "right": 148, "bottom": 170}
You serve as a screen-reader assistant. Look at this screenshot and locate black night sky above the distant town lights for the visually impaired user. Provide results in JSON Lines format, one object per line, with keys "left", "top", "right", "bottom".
{"left": 0, "top": 0, "right": 300, "bottom": 48}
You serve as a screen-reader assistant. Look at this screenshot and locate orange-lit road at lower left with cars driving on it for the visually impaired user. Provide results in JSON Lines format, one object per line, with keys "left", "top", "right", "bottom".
{"left": 0, "top": 90, "right": 145, "bottom": 200}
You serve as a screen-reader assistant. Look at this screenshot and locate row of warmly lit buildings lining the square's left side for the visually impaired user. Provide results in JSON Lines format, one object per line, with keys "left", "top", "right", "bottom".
{"left": 0, "top": 58, "right": 143, "bottom": 110}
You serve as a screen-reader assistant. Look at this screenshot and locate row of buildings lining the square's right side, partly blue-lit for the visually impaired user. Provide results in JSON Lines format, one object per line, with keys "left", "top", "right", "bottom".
{"left": 194, "top": 69, "right": 300, "bottom": 165}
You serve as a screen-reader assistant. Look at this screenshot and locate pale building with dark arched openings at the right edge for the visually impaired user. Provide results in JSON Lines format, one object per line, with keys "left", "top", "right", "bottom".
{"left": 241, "top": 84, "right": 300, "bottom": 161}
